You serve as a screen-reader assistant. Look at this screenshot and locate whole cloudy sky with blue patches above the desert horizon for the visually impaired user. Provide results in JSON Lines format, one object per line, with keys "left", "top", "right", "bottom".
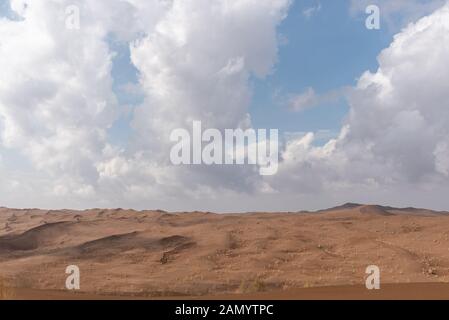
{"left": 0, "top": 0, "right": 449, "bottom": 212}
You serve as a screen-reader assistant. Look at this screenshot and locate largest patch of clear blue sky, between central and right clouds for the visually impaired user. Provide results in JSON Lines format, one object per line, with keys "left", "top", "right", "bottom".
{"left": 251, "top": 0, "right": 391, "bottom": 136}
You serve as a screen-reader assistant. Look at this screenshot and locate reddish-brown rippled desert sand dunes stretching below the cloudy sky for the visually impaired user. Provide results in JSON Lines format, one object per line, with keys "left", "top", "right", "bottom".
{"left": 0, "top": 204, "right": 449, "bottom": 300}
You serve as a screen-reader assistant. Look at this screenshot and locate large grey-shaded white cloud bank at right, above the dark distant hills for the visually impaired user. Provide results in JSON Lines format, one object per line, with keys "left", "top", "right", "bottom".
{"left": 271, "top": 4, "right": 449, "bottom": 206}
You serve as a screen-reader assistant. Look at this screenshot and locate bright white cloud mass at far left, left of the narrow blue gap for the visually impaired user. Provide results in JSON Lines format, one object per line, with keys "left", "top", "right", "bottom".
{"left": 0, "top": 0, "right": 172, "bottom": 205}
